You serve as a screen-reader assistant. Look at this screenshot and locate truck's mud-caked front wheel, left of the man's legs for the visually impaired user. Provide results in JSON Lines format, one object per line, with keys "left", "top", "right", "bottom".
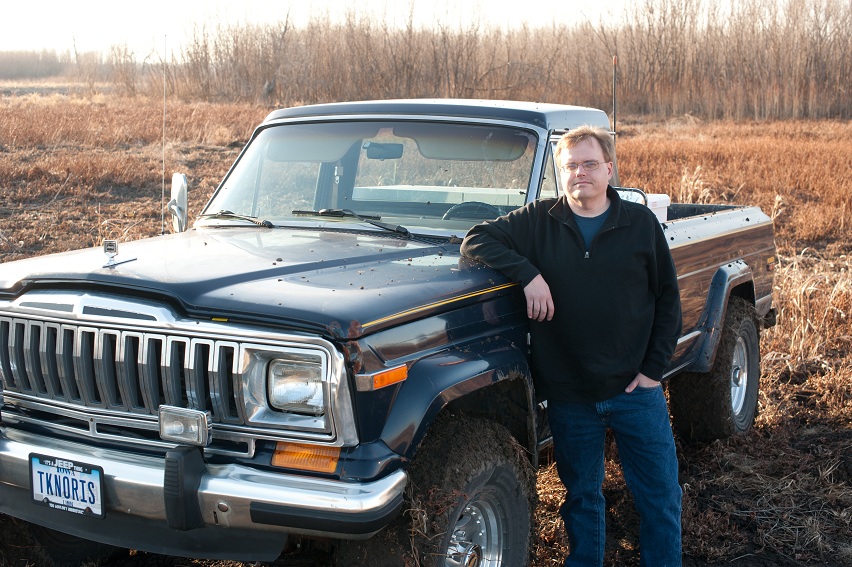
{"left": 409, "top": 415, "right": 536, "bottom": 567}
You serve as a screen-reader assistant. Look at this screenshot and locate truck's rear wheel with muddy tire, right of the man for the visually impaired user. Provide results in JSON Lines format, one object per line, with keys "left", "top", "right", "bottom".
{"left": 668, "top": 297, "right": 760, "bottom": 442}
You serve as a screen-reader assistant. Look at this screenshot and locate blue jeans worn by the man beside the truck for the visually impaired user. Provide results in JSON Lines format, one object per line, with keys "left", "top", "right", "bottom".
{"left": 548, "top": 386, "right": 683, "bottom": 567}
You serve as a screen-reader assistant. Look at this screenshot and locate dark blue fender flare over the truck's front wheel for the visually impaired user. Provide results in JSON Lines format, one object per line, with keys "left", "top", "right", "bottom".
{"left": 381, "top": 338, "right": 535, "bottom": 459}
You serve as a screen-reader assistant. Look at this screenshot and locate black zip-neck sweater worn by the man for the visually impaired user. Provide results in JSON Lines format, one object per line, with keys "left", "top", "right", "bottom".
{"left": 461, "top": 187, "right": 682, "bottom": 402}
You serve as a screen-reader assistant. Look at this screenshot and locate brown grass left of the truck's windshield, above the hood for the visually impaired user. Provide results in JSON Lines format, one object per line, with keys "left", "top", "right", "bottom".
{"left": 0, "top": 94, "right": 266, "bottom": 261}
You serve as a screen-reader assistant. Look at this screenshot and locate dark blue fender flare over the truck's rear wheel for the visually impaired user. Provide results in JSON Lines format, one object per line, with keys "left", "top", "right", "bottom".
{"left": 687, "top": 260, "right": 754, "bottom": 373}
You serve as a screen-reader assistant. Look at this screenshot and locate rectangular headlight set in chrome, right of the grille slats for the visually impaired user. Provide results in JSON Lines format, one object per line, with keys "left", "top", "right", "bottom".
{"left": 267, "top": 359, "right": 326, "bottom": 415}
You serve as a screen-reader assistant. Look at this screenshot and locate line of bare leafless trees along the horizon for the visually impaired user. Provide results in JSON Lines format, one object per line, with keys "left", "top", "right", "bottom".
{"left": 0, "top": 0, "right": 852, "bottom": 120}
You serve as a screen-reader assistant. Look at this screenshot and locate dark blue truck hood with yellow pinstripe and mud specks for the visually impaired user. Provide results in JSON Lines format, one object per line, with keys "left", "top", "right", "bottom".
{"left": 0, "top": 227, "right": 509, "bottom": 338}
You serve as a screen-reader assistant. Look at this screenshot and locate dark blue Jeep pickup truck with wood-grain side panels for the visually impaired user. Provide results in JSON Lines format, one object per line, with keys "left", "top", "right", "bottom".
{"left": 0, "top": 100, "right": 775, "bottom": 567}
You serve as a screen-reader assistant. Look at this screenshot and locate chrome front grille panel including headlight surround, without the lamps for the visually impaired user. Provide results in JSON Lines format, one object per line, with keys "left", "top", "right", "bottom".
{"left": 0, "top": 290, "right": 358, "bottom": 455}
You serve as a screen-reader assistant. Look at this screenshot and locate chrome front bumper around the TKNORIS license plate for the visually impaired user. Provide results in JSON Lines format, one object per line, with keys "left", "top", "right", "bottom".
{"left": 0, "top": 428, "right": 407, "bottom": 561}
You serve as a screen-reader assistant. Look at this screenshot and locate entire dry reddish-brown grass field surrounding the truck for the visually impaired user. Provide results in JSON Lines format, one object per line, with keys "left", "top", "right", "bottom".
{"left": 0, "top": 94, "right": 852, "bottom": 567}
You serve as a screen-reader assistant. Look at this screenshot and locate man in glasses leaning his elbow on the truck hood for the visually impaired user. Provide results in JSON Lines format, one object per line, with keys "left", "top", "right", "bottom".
{"left": 462, "top": 126, "right": 682, "bottom": 567}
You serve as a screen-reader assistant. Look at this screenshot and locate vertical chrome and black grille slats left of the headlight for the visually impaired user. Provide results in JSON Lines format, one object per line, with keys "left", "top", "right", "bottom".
{"left": 0, "top": 317, "right": 245, "bottom": 424}
